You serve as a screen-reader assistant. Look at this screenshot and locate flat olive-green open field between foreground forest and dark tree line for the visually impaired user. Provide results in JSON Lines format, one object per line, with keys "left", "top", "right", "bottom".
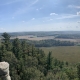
{"left": 41, "top": 46, "right": 80, "bottom": 63}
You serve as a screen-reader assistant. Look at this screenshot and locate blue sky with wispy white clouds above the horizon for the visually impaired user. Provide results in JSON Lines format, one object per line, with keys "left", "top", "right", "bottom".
{"left": 0, "top": 0, "right": 80, "bottom": 32}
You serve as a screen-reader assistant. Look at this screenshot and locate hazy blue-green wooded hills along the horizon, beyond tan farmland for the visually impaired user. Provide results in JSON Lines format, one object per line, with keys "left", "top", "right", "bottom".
{"left": 0, "top": 31, "right": 80, "bottom": 37}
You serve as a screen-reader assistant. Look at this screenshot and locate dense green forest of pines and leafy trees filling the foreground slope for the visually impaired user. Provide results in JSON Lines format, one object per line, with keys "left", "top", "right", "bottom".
{"left": 0, "top": 33, "right": 80, "bottom": 80}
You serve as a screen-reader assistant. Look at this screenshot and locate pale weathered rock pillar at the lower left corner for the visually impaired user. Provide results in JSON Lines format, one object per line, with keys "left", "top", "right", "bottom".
{"left": 0, "top": 62, "right": 11, "bottom": 80}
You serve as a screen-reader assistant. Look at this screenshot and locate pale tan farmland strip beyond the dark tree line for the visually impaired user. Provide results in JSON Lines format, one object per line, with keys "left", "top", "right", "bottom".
{"left": 11, "top": 35, "right": 80, "bottom": 42}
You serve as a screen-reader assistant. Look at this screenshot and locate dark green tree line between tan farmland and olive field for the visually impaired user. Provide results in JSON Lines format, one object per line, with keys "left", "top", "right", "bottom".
{"left": 28, "top": 39, "right": 75, "bottom": 47}
